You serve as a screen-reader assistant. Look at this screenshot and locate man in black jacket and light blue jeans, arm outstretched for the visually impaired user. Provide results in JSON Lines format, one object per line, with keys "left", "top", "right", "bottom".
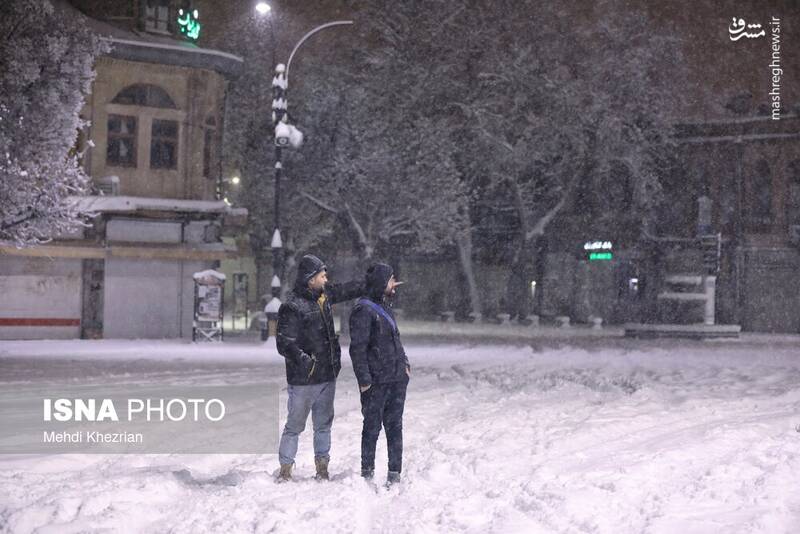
{"left": 277, "top": 255, "right": 364, "bottom": 481}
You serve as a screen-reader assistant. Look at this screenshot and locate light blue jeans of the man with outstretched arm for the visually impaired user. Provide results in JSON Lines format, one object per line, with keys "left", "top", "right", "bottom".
{"left": 278, "top": 380, "right": 336, "bottom": 465}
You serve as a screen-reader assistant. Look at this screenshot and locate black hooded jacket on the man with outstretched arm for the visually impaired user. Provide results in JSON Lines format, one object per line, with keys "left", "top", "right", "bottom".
{"left": 277, "top": 255, "right": 364, "bottom": 386}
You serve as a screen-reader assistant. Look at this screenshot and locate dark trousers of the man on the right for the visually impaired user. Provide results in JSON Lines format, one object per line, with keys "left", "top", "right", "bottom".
{"left": 361, "top": 380, "right": 408, "bottom": 473}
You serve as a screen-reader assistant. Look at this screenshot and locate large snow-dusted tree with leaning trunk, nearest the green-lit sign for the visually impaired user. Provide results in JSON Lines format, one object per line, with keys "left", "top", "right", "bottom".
{"left": 438, "top": 0, "right": 681, "bottom": 316}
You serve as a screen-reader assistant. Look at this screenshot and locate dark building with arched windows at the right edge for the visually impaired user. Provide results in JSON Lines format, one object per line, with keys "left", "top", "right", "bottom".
{"left": 671, "top": 113, "right": 800, "bottom": 333}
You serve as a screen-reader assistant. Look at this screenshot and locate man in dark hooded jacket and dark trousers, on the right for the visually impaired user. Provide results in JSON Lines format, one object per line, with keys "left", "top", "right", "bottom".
{"left": 350, "top": 263, "right": 411, "bottom": 484}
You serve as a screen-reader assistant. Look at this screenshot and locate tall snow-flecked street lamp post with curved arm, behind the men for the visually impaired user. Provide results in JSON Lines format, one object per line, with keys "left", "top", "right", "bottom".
{"left": 256, "top": 2, "right": 353, "bottom": 338}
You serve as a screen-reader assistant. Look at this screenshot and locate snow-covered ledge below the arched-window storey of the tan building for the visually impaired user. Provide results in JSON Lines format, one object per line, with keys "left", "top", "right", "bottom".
{"left": 70, "top": 195, "right": 233, "bottom": 213}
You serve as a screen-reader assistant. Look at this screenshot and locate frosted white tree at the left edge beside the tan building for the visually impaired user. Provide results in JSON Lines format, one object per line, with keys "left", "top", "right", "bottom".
{"left": 0, "top": 0, "right": 107, "bottom": 246}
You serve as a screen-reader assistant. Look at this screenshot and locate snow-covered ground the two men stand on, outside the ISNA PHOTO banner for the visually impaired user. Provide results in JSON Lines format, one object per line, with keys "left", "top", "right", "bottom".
{"left": 0, "top": 338, "right": 800, "bottom": 534}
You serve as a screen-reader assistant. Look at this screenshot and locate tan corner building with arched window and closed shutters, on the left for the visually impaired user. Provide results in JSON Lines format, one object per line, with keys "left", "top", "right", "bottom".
{"left": 0, "top": 0, "right": 246, "bottom": 339}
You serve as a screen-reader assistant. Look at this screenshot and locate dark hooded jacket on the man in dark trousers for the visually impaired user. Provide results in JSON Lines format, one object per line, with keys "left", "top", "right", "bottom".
{"left": 350, "top": 263, "right": 409, "bottom": 387}
